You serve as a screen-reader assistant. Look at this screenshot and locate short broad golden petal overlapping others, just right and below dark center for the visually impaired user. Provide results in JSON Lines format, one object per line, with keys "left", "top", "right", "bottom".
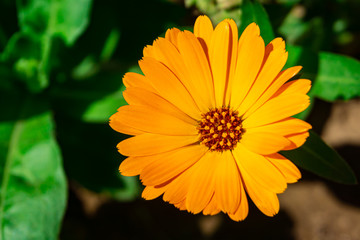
{"left": 240, "top": 131, "right": 291, "bottom": 155}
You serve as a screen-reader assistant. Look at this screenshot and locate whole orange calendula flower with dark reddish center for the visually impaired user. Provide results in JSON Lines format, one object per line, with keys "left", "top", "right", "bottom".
{"left": 110, "top": 16, "right": 311, "bottom": 221}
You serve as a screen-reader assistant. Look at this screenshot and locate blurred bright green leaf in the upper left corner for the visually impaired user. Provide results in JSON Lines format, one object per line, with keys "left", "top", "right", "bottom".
{"left": 0, "top": 0, "right": 92, "bottom": 93}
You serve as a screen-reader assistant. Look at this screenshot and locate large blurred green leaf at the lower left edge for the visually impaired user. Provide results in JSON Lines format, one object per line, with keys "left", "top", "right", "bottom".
{"left": 0, "top": 94, "right": 66, "bottom": 240}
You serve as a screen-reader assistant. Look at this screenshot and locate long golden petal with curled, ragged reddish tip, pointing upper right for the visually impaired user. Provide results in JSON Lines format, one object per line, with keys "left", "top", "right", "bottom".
{"left": 237, "top": 37, "right": 288, "bottom": 115}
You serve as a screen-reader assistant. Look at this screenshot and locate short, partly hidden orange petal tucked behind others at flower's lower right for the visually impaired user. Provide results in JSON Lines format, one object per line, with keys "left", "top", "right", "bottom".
{"left": 266, "top": 153, "right": 301, "bottom": 183}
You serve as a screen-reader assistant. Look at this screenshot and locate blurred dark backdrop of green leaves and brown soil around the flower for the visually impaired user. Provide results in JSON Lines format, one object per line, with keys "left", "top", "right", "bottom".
{"left": 0, "top": 0, "right": 360, "bottom": 240}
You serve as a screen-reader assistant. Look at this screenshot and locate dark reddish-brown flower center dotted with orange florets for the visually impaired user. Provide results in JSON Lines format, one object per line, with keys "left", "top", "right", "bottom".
{"left": 198, "top": 107, "right": 243, "bottom": 152}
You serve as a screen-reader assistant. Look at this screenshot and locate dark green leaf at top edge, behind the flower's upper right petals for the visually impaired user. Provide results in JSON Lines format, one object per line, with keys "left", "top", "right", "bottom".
{"left": 239, "top": 0, "right": 275, "bottom": 44}
